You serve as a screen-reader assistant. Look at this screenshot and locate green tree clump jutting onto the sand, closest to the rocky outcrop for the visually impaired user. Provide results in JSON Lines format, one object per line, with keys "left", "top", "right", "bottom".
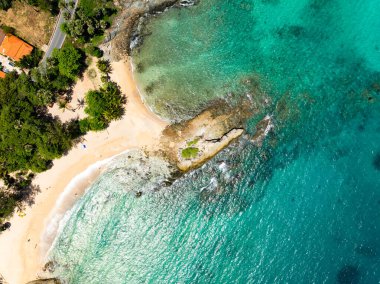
{"left": 79, "top": 82, "right": 126, "bottom": 132}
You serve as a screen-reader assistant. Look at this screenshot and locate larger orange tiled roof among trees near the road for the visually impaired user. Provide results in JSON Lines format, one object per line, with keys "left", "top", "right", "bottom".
{"left": 0, "top": 34, "right": 33, "bottom": 61}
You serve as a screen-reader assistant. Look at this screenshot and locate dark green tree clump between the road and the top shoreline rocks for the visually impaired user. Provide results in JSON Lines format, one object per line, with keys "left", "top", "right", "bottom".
{"left": 61, "top": 0, "right": 116, "bottom": 45}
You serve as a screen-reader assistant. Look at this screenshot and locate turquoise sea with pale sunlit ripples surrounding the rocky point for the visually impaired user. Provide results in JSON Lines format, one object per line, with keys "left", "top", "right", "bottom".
{"left": 50, "top": 0, "right": 380, "bottom": 283}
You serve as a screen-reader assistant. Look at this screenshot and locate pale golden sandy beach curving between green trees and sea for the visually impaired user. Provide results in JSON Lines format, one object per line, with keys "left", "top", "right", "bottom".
{"left": 0, "top": 62, "right": 167, "bottom": 284}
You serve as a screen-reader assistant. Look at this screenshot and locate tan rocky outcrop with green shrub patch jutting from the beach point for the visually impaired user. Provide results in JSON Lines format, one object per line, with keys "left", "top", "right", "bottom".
{"left": 160, "top": 101, "right": 252, "bottom": 172}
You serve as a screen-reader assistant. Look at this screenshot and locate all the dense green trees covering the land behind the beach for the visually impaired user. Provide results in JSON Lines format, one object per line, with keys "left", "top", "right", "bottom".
{"left": 0, "top": 0, "right": 126, "bottom": 227}
